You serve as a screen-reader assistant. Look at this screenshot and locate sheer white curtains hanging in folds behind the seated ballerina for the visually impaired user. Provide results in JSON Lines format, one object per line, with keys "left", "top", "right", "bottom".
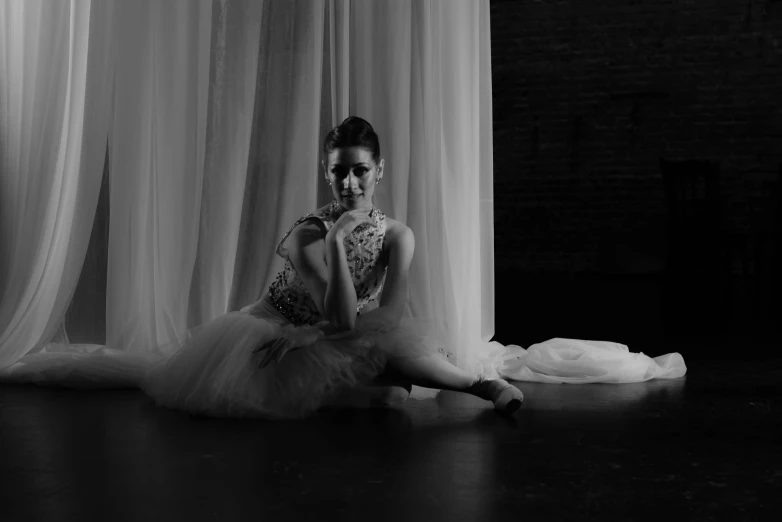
{"left": 0, "top": 0, "right": 494, "bottom": 384}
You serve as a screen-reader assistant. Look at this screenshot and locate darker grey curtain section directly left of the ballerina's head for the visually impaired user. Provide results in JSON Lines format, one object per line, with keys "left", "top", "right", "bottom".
{"left": 230, "top": 0, "right": 327, "bottom": 310}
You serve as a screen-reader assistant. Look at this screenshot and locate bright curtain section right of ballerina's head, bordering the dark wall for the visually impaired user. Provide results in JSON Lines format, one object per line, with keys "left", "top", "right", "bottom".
{"left": 350, "top": 0, "right": 494, "bottom": 369}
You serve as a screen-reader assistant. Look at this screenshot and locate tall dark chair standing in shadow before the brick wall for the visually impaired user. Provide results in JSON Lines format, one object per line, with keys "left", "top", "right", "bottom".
{"left": 660, "top": 158, "right": 729, "bottom": 338}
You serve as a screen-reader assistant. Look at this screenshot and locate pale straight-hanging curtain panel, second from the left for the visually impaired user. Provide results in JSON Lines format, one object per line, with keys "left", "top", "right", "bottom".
{"left": 106, "top": 0, "right": 212, "bottom": 351}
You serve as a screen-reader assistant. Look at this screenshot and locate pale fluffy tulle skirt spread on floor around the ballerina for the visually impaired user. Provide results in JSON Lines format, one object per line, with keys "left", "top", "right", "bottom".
{"left": 141, "top": 298, "right": 439, "bottom": 418}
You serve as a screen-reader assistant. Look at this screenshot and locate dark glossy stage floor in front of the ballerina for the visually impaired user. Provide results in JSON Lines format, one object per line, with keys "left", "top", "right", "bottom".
{"left": 0, "top": 353, "right": 782, "bottom": 522}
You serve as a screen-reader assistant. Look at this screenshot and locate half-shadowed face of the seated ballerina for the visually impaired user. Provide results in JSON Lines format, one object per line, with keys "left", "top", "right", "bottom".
{"left": 323, "top": 147, "right": 384, "bottom": 210}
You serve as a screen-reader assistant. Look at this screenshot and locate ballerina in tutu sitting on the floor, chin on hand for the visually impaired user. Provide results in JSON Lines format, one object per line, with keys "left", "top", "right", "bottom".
{"left": 141, "top": 117, "right": 523, "bottom": 418}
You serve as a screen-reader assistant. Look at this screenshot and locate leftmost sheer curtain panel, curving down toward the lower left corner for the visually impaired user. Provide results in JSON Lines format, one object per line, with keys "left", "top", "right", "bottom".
{"left": 0, "top": 0, "right": 113, "bottom": 368}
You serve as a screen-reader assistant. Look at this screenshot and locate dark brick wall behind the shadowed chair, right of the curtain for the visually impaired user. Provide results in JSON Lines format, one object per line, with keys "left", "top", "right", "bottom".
{"left": 491, "top": 0, "right": 782, "bottom": 272}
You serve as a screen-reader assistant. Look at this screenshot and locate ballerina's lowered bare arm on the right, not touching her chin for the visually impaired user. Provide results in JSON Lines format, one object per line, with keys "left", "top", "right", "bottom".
{"left": 356, "top": 225, "right": 415, "bottom": 328}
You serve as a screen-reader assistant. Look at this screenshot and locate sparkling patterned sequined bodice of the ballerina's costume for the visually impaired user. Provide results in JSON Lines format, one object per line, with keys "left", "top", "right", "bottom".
{"left": 269, "top": 200, "right": 386, "bottom": 325}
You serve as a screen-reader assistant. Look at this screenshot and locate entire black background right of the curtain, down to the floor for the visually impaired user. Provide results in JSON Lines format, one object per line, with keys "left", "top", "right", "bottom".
{"left": 491, "top": 0, "right": 782, "bottom": 359}
